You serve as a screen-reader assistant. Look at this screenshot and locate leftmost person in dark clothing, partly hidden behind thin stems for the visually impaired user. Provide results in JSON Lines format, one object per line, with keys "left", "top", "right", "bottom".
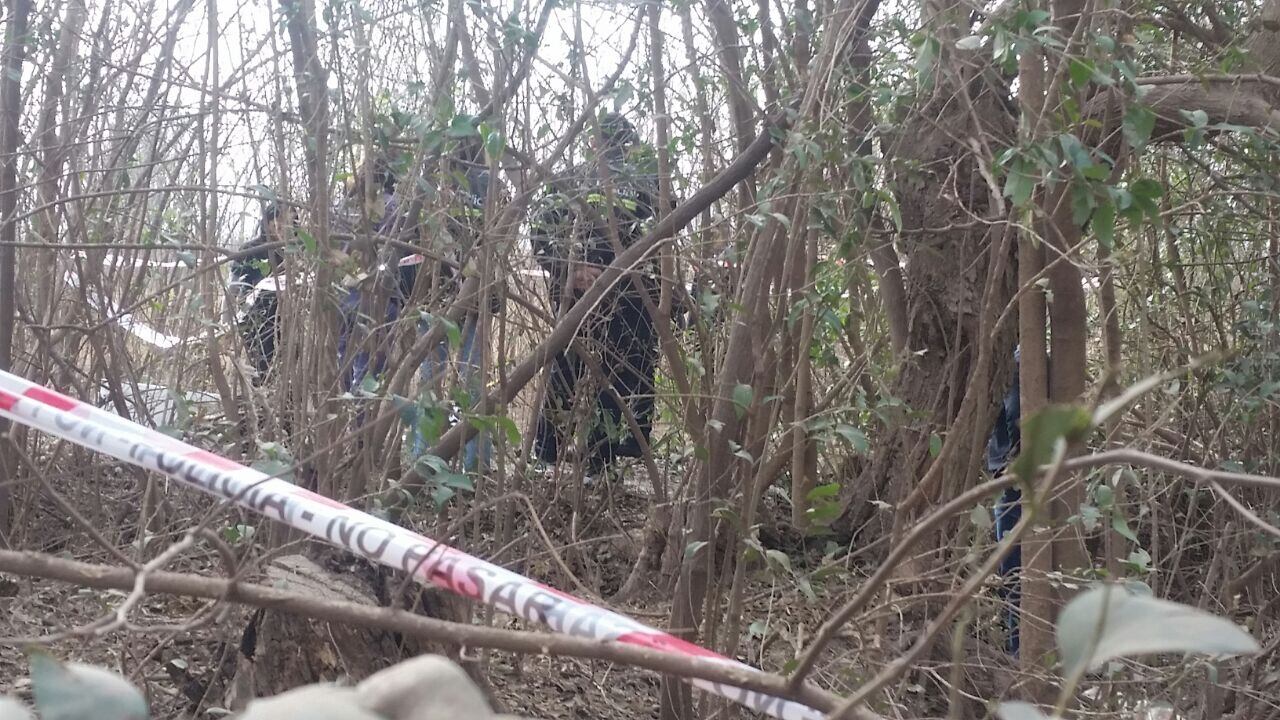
{"left": 230, "top": 201, "right": 292, "bottom": 383}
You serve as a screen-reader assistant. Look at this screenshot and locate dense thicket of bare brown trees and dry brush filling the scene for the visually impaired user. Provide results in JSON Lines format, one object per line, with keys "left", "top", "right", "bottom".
{"left": 0, "top": 0, "right": 1280, "bottom": 720}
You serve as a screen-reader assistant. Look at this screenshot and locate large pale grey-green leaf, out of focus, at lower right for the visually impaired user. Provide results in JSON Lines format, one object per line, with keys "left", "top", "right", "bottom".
{"left": 1056, "top": 585, "right": 1261, "bottom": 676}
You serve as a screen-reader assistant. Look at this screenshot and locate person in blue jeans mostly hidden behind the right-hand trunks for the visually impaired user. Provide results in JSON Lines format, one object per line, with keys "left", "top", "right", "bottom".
{"left": 987, "top": 348, "right": 1023, "bottom": 656}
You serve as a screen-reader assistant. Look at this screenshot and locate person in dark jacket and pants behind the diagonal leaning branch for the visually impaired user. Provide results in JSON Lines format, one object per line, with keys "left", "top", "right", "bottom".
{"left": 531, "top": 113, "right": 658, "bottom": 473}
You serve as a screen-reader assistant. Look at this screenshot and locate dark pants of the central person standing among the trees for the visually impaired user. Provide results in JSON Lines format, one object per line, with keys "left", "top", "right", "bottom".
{"left": 535, "top": 292, "right": 658, "bottom": 473}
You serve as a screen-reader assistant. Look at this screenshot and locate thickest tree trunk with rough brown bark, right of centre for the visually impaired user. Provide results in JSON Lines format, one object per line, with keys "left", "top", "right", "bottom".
{"left": 837, "top": 0, "right": 1015, "bottom": 534}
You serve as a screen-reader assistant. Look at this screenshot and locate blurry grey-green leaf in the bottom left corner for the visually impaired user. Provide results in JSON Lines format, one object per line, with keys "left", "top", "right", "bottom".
{"left": 31, "top": 651, "right": 148, "bottom": 720}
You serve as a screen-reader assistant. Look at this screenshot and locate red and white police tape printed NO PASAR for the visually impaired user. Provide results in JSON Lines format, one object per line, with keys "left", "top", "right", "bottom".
{"left": 0, "top": 372, "right": 823, "bottom": 720}
